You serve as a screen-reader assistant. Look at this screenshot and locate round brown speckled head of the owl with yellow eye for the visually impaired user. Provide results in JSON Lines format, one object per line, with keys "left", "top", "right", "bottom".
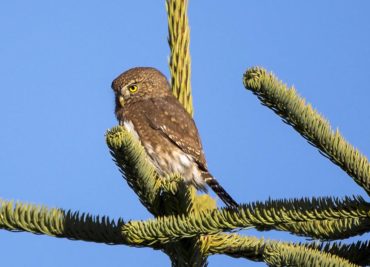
{"left": 112, "top": 67, "right": 171, "bottom": 108}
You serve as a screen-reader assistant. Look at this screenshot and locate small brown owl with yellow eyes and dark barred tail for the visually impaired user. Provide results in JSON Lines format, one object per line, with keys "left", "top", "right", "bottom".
{"left": 112, "top": 67, "right": 237, "bottom": 207}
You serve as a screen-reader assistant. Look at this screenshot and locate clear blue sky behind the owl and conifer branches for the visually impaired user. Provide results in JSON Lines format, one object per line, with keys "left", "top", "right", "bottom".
{"left": 0, "top": 0, "right": 370, "bottom": 266}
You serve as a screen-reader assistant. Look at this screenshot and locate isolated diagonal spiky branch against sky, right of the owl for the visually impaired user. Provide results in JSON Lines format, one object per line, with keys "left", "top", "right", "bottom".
{"left": 243, "top": 67, "right": 370, "bottom": 195}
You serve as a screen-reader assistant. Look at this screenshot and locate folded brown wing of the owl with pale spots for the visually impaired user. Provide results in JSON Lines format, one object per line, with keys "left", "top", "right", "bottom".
{"left": 142, "top": 95, "right": 207, "bottom": 171}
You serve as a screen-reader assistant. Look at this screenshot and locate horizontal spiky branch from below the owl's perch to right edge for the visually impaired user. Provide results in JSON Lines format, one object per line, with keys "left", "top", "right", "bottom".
{"left": 122, "top": 197, "right": 370, "bottom": 245}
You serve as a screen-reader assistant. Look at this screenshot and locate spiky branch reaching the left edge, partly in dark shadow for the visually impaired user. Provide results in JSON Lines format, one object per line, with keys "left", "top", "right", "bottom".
{"left": 0, "top": 200, "right": 132, "bottom": 245}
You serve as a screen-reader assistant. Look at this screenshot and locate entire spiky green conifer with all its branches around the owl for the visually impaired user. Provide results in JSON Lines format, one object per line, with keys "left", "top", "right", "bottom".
{"left": 0, "top": 0, "right": 370, "bottom": 266}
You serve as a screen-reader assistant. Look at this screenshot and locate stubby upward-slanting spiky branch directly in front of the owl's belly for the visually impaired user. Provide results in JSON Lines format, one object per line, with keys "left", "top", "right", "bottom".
{"left": 106, "top": 126, "right": 216, "bottom": 219}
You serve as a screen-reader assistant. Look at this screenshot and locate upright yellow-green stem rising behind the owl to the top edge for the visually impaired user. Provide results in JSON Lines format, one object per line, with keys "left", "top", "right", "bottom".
{"left": 166, "top": 0, "right": 193, "bottom": 115}
